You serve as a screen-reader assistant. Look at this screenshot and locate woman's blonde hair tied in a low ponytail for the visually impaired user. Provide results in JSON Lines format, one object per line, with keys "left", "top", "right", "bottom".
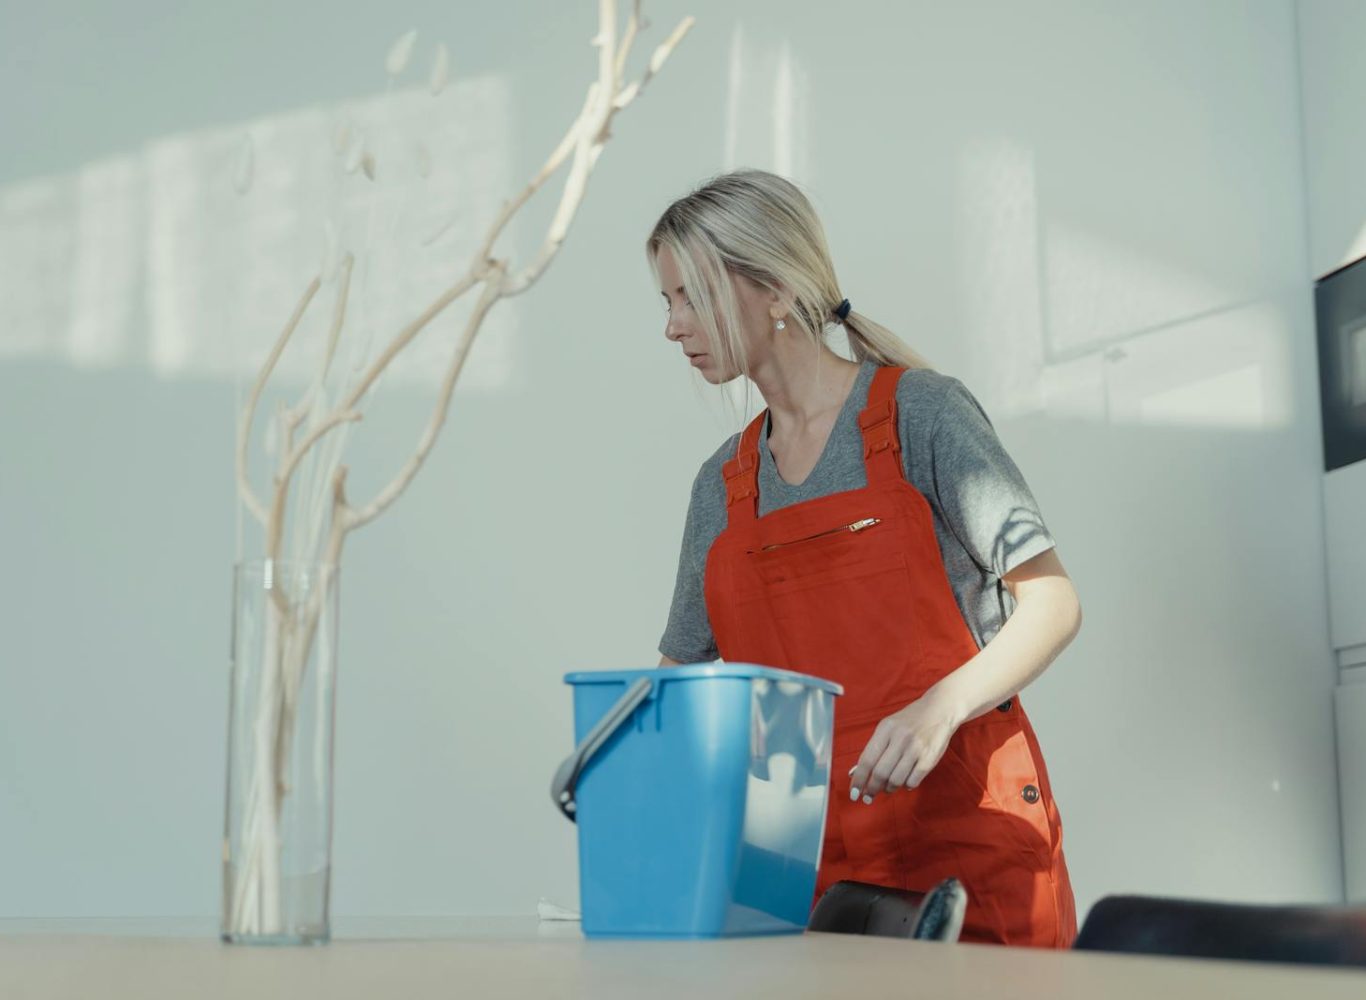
{"left": 645, "top": 169, "right": 930, "bottom": 376}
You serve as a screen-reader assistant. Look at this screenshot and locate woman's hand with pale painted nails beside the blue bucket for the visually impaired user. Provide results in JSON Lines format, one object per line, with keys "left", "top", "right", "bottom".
{"left": 850, "top": 689, "right": 962, "bottom": 802}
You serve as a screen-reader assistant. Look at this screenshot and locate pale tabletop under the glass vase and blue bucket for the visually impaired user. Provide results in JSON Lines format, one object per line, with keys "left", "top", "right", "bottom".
{"left": 0, "top": 917, "right": 1366, "bottom": 1000}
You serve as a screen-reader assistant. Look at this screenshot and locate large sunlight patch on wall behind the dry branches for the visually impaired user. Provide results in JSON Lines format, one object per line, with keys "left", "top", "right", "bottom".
{"left": 0, "top": 77, "right": 518, "bottom": 389}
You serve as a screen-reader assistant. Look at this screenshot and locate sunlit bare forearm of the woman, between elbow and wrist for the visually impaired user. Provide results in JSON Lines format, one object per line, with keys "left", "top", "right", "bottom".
{"left": 925, "top": 578, "right": 1082, "bottom": 725}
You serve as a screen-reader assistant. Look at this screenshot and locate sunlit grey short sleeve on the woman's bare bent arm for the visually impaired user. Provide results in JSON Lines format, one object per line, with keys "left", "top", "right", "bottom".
{"left": 930, "top": 378, "right": 1056, "bottom": 577}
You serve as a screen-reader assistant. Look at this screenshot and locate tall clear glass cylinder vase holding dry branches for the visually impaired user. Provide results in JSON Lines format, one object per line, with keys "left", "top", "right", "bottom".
{"left": 221, "top": 560, "right": 339, "bottom": 944}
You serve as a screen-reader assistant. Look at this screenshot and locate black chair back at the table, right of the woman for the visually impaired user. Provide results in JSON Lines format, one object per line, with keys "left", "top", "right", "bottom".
{"left": 1072, "top": 896, "right": 1366, "bottom": 967}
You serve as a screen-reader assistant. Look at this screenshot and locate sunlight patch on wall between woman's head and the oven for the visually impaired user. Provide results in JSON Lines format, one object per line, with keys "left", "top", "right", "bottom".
{"left": 955, "top": 138, "right": 1294, "bottom": 430}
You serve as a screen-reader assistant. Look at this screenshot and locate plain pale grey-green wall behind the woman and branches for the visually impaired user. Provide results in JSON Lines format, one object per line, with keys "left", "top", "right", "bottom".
{"left": 0, "top": 0, "right": 1341, "bottom": 917}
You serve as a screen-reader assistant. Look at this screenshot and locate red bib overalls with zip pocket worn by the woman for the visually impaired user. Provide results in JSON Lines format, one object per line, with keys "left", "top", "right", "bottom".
{"left": 705, "top": 367, "right": 1076, "bottom": 948}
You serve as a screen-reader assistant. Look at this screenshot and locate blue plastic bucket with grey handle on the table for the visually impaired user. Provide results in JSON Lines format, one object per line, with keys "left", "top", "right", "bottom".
{"left": 552, "top": 663, "right": 843, "bottom": 937}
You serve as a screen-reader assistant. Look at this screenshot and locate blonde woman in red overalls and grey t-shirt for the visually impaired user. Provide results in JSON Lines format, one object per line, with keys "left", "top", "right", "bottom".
{"left": 646, "top": 171, "right": 1081, "bottom": 948}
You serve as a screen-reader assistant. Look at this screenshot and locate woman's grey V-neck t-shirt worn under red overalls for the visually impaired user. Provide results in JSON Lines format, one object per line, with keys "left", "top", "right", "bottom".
{"left": 660, "top": 361, "right": 1055, "bottom": 663}
